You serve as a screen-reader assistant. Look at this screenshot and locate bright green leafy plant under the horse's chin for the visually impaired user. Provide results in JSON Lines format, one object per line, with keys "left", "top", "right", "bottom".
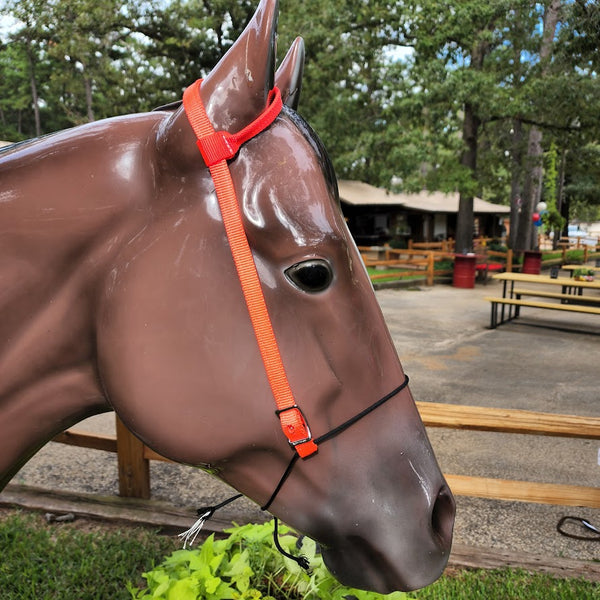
{"left": 127, "top": 521, "right": 407, "bottom": 600}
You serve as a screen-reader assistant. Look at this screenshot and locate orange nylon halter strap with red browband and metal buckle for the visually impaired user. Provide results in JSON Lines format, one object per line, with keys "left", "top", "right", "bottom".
{"left": 183, "top": 80, "right": 317, "bottom": 458}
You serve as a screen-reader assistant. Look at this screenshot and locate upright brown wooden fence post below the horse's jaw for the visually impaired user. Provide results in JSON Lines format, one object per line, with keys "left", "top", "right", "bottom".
{"left": 116, "top": 416, "right": 150, "bottom": 500}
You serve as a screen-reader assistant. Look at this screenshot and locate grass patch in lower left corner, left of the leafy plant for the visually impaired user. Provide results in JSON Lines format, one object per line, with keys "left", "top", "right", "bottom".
{"left": 0, "top": 511, "right": 175, "bottom": 600}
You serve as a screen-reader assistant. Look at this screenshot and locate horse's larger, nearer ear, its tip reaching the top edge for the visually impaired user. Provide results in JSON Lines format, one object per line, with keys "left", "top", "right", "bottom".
{"left": 200, "top": 0, "right": 279, "bottom": 132}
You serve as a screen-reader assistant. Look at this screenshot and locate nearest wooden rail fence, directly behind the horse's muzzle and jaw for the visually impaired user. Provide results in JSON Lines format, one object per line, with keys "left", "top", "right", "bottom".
{"left": 53, "top": 402, "right": 600, "bottom": 508}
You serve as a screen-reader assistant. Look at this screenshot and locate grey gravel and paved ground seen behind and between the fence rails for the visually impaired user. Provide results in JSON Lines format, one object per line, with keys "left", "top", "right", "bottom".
{"left": 5, "top": 282, "right": 600, "bottom": 560}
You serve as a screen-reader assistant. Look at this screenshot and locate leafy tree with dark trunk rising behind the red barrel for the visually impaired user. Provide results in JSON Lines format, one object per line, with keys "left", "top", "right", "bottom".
{"left": 386, "top": 0, "right": 534, "bottom": 251}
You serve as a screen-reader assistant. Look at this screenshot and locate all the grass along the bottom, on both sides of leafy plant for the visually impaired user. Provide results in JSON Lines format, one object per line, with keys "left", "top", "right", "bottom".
{"left": 0, "top": 511, "right": 600, "bottom": 600}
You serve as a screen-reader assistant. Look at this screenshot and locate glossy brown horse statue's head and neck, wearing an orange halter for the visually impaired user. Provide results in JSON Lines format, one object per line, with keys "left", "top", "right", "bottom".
{"left": 0, "top": 0, "right": 454, "bottom": 592}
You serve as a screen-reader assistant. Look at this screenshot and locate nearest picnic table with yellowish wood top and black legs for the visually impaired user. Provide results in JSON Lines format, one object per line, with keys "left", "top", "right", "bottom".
{"left": 485, "top": 273, "right": 600, "bottom": 329}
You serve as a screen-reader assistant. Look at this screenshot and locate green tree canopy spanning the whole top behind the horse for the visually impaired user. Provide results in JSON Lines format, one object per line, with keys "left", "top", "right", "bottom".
{"left": 0, "top": 0, "right": 600, "bottom": 244}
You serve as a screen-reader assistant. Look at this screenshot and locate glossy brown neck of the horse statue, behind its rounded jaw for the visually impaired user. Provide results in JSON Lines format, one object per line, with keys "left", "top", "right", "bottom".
{"left": 0, "top": 117, "right": 162, "bottom": 489}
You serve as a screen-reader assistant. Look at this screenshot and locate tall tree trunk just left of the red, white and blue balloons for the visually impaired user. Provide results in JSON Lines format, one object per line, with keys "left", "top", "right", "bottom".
{"left": 515, "top": 0, "right": 561, "bottom": 252}
